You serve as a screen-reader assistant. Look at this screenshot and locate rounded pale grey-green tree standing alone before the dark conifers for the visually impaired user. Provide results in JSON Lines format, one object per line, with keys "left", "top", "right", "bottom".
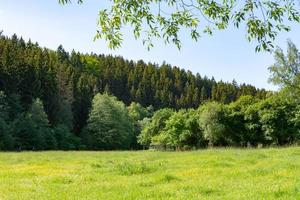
{"left": 87, "top": 94, "right": 133, "bottom": 150}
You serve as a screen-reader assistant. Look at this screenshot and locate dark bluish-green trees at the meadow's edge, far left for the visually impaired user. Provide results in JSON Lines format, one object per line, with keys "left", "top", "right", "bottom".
{"left": 0, "top": 92, "right": 81, "bottom": 150}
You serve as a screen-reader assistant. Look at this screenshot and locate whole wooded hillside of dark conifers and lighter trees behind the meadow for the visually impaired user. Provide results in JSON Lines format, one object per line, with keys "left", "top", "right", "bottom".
{"left": 0, "top": 34, "right": 300, "bottom": 151}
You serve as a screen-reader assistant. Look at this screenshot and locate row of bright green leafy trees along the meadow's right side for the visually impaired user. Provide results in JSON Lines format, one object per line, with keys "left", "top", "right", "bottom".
{"left": 139, "top": 94, "right": 300, "bottom": 149}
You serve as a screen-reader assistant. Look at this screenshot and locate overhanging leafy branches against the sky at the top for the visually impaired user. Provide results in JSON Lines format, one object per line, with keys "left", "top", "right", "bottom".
{"left": 59, "top": 0, "right": 300, "bottom": 51}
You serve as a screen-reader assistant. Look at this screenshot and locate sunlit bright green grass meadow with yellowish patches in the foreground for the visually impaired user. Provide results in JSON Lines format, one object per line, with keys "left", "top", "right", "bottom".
{"left": 0, "top": 147, "right": 300, "bottom": 200}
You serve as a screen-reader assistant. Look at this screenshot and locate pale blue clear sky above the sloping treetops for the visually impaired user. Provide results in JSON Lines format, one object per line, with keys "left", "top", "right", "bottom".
{"left": 0, "top": 0, "right": 300, "bottom": 89}
